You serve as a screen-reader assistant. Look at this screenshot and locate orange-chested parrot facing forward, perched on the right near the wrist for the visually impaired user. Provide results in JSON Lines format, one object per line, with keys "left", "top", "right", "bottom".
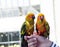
{"left": 36, "top": 13, "right": 50, "bottom": 39}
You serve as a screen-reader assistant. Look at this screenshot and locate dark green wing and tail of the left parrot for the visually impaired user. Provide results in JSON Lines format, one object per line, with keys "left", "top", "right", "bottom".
{"left": 20, "top": 22, "right": 28, "bottom": 47}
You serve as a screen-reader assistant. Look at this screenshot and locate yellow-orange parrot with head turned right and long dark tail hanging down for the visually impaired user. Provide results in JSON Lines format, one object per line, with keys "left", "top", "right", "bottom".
{"left": 20, "top": 13, "right": 35, "bottom": 47}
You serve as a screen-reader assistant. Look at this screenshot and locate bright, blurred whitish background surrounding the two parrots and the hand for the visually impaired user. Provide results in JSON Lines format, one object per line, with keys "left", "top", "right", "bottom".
{"left": 0, "top": 0, "right": 60, "bottom": 47}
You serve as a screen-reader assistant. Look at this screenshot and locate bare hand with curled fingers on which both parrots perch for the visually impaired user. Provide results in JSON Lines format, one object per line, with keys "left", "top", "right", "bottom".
{"left": 24, "top": 34, "right": 52, "bottom": 47}
